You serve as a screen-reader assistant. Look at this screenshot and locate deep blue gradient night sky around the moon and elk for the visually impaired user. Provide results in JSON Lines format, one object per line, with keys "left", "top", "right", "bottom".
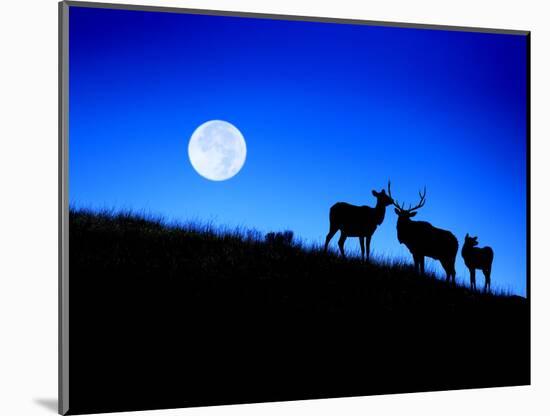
{"left": 69, "top": 6, "right": 527, "bottom": 295}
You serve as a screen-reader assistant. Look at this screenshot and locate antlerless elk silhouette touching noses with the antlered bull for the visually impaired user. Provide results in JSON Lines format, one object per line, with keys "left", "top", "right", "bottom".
{"left": 325, "top": 182, "right": 393, "bottom": 261}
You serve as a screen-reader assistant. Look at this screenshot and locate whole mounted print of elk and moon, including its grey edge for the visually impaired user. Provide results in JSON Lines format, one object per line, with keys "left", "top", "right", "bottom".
{"left": 60, "top": 2, "right": 530, "bottom": 414}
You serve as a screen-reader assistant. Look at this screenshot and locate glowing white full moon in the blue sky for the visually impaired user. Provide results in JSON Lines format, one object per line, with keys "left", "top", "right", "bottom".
{"left": 188, "top": 120, "right": 246, "bottom": 181}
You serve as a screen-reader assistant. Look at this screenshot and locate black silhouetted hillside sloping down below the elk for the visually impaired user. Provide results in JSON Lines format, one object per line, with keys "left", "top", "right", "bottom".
{"left": 69, "top": 211, "right": 530, "bottom": 413}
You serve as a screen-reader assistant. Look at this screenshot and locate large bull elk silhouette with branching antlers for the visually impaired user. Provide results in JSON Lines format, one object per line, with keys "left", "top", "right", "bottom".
{"left": 388, "top": 186, "right": 458, "bottom": 284}
